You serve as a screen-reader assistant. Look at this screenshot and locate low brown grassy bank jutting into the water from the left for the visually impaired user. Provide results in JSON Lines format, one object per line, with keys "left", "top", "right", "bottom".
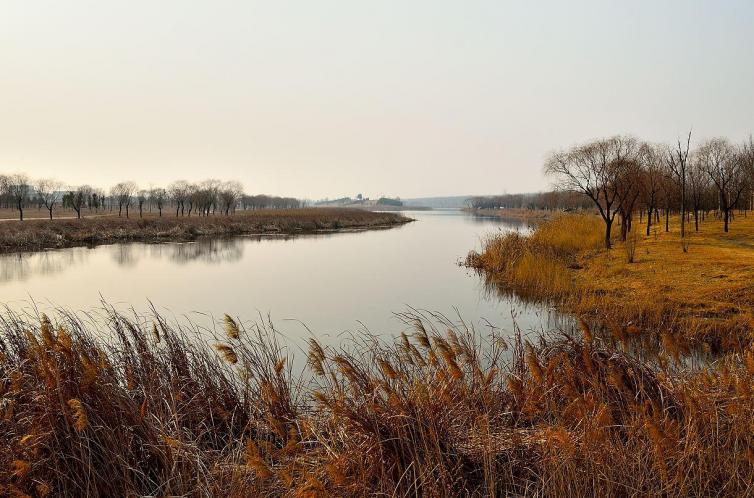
{"left": 0, "top": 208, "right": 410, "bottom": 252}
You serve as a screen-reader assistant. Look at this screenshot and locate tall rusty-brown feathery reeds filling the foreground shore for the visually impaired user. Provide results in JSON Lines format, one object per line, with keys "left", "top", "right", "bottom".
{"left": 0, "top": 312, "right": 754, "bottom": 497}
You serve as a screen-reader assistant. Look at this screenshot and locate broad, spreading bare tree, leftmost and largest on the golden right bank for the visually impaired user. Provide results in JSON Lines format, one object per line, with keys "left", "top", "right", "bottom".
{"left": 545, "top": 136, "right": 637, "bottom": 249}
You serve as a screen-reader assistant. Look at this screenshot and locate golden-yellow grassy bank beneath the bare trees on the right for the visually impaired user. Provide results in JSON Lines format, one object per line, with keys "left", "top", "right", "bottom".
{"left": 467, "top": 215, "right": 754, "bottom": 350}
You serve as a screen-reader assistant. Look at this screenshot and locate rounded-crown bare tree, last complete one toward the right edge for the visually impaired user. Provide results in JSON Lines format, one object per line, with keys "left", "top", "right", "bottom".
{"left": 697, "top": 138, "right": 747, "bottom": 232}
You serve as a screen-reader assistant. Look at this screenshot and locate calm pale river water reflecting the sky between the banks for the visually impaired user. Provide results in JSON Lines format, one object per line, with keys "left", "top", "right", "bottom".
{"left": 0, "top": 211, "right": 548, "bottom": 341}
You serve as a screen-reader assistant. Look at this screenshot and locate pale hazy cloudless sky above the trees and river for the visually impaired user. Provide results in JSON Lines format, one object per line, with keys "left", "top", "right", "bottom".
{"left": 0, "top": 0, "right": 754, "bottom": 199}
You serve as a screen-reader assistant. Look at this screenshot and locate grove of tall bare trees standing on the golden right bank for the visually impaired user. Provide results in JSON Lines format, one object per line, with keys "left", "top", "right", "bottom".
{"left": 545, "top": 133, "right": 754, "bottom": 248}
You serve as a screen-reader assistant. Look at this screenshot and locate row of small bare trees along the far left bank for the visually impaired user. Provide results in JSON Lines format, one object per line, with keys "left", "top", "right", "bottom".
{"left": 0, "top": 173, "right": 303, "bottom": 220}
